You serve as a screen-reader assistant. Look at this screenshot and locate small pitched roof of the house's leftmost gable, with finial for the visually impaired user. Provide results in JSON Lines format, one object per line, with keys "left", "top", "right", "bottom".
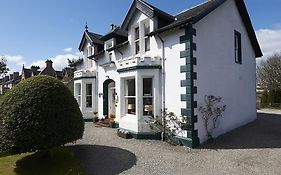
{"left": 79, "top": 30, "right": 103, "bottom": 51}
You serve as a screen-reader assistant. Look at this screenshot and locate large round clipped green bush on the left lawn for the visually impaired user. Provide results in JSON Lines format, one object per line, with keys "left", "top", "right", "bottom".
{"left": 0, "top": 76, "right": 84, "bottom": 153}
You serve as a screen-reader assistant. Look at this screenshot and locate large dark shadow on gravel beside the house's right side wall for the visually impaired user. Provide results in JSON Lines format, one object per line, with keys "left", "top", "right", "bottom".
{"left": 199, "top": 113, "right": 281, "bottom": 149}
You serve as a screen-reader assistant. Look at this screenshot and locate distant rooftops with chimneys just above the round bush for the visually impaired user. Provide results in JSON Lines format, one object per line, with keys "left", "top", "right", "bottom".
{"left": 21, "top": 60, "right": 63, "bottom": 80}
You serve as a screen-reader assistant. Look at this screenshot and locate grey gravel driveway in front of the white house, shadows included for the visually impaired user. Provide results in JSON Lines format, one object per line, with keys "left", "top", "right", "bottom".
{"left": 71, "top": 113, "right": 281, "bottom": 175}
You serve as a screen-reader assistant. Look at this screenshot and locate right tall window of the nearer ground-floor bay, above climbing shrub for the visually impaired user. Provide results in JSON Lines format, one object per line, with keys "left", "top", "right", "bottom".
{"left": 143, "top": 78, "right": 153, "bottom": 115}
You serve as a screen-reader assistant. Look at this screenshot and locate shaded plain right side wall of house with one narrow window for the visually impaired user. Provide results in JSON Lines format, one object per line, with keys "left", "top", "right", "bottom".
{"left": 193, "top": 0, "right": 256, "bottom": 143}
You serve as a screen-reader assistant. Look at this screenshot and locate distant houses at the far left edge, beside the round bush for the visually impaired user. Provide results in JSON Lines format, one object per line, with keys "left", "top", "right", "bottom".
{"left": 0, "top": 72, "right": 21, "bottom": 95}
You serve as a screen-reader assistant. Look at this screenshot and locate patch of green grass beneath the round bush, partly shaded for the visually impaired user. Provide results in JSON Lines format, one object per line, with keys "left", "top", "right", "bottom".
{"left": 0, "top": 147, "right": 85, "bottom": 175}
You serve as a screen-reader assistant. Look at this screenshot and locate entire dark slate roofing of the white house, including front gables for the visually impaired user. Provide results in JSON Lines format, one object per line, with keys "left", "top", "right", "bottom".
{"left": 79, "top": 0, "right": 262, "bottom": 58}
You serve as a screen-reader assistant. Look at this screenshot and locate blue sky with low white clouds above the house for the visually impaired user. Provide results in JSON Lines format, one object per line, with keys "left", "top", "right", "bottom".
{"left": 0, "top": 0, "right": 281, "bottom": 71}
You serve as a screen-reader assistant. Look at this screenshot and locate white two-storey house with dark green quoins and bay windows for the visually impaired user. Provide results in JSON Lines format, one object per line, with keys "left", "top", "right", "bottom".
{"left": 74, "top": 0, "right": 262, "bottom": 147}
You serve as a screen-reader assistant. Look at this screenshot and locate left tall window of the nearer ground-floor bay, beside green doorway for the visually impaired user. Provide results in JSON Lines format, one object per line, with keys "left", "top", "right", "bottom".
{"left": 125, "top": 79, "right": 136, "bottom": 114}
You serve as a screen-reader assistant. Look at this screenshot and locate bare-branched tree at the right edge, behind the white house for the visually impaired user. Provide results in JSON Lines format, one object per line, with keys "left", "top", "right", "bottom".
{"left": 257, "top": 53, "right": 281, "bottom": 91}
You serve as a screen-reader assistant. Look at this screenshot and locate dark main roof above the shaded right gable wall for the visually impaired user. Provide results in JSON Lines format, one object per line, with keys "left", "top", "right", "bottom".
{"left": 149, "top": 0, "right": 263, "bottom": 57}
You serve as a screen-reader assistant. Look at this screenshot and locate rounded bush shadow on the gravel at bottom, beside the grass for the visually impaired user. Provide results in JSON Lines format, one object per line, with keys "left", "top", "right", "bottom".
{"left": 68, "top": 145, "right": 137, "bottom": 175}
